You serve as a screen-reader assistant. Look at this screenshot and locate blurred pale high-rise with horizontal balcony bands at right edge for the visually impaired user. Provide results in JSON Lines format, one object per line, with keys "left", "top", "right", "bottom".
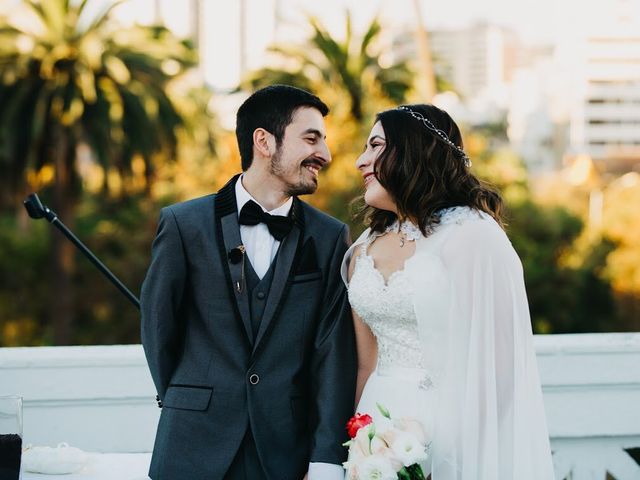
{"left": 570, "top": 0, "right": 640, "bottom": 171}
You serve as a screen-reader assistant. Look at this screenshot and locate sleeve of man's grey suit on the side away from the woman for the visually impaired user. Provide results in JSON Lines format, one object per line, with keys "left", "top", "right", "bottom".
{"left": 140, "top": 208, "right": 187, "bottom": 399}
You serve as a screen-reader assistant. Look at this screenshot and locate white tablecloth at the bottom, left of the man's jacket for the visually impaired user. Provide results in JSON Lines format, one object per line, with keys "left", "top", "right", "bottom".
{"left": 20, "top": 453, "right": 151, "bottom": 480}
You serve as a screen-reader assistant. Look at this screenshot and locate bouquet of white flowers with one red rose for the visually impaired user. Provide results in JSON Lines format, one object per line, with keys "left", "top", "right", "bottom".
{"left": 343, "top": 405, "right": 429, "bottom": 480}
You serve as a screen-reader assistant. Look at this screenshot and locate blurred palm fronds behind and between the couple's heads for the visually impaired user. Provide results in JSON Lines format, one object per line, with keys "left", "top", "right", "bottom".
{"left": 242, "top": 12, "right": 413, "bottom": 122}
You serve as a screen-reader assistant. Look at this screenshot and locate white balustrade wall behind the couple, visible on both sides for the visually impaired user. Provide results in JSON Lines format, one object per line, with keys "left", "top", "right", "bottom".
{"left": 0, "top": 333, "right": 640, "bottom": 480}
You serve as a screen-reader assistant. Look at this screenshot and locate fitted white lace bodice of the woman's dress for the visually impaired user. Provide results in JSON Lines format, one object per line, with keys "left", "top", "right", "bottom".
{"left": 349, "top": 236, "right": 422, "bottom": 367}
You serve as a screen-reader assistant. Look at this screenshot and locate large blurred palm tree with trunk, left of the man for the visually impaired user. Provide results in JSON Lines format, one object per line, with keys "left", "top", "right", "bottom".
{"left": 0, "top": 0, "right": 196, "bottom": 344}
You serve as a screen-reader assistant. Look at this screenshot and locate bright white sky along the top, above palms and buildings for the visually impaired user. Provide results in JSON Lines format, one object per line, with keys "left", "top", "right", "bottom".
{"left": 0, "top": 0, "right": 640, "bottom": 91}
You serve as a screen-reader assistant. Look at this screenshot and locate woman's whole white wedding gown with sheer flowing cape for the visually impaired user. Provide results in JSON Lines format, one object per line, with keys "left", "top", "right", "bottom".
{"left": 343, "top": 207, "right": 553, "bottom": 480}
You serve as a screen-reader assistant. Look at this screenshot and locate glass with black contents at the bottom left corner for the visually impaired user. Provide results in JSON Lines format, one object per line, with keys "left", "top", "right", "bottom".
{"left": 0, "top": 395, "right": 22, "bottom": 480}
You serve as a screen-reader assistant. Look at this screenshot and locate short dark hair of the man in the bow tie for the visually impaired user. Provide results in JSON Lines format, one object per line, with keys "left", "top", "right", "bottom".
{"left": 236, "top": 85, "right": 329, "bottom": 171}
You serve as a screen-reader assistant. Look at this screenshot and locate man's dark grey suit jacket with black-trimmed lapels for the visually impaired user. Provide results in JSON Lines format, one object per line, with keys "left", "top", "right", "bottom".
{"left": 141, "top": 177, "right": 356, "bottom": 480}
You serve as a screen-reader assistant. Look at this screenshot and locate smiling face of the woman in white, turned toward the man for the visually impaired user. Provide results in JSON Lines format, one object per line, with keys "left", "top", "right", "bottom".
{"left": 356, "top": 122, "right": 397, "bottom": 212}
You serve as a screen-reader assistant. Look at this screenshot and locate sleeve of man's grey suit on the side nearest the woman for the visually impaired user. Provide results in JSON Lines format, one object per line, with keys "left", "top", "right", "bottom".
{"left": 310, "top": 225, "right": 357, "bottom": 464}
